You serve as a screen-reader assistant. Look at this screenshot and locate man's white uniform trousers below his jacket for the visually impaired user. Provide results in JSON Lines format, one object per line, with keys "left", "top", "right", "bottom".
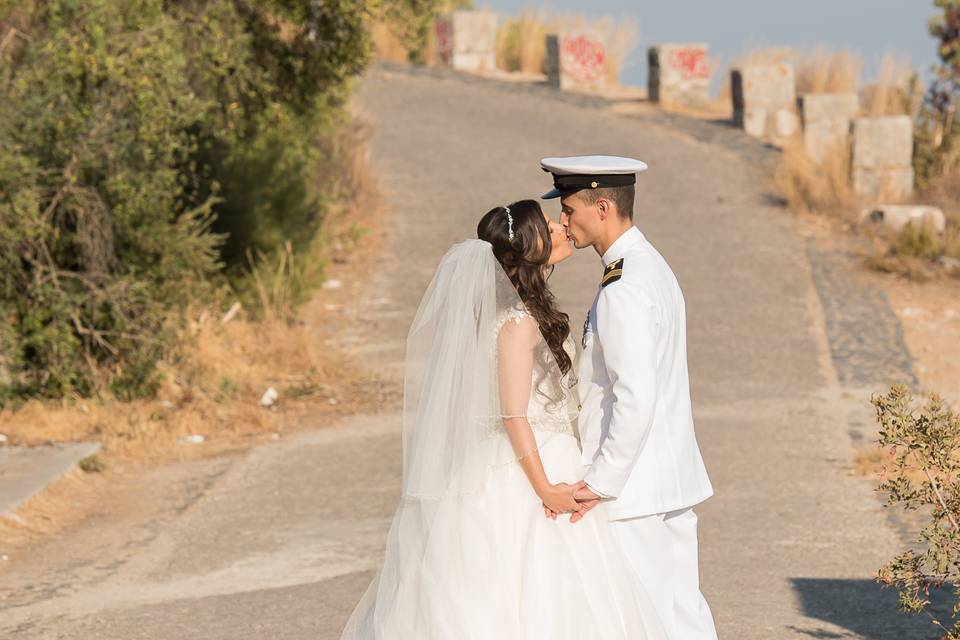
{"left": 610, "top": 509, "right": 717, "bottom": 640}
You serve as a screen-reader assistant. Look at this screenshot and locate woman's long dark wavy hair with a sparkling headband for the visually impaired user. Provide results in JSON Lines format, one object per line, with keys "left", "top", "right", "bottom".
{"left": 477, "top": 200, "right": 572, "bottom": 373}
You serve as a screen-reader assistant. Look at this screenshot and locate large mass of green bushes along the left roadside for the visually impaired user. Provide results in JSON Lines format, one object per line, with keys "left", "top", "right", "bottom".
{"left": 0, "top": 0, "right": 450, "bottom": 403}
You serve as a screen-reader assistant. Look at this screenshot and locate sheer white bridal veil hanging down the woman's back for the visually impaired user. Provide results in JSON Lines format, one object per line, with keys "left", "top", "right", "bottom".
{"left": 403, "top": 240, "right": 565, "bottom": 500}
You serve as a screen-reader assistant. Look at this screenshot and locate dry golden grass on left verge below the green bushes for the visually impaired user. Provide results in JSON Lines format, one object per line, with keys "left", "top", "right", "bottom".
{"left": 0, "top": 110, "right": 396, "bottom": 461}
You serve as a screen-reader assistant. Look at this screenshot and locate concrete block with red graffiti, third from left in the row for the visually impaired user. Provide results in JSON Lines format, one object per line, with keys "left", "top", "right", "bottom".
{"left": 647, "top": 44, "right": 710, "bottom": 106}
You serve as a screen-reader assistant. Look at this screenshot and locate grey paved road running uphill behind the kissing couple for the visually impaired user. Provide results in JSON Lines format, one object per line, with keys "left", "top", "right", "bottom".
{"left": 0, "top": 69, "right": 930, "bottom": 640}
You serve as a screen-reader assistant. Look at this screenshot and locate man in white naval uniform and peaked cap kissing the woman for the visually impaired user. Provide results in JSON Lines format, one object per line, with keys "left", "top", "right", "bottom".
{"left": 540, "top": 156, "right": 717, "bottom": 640}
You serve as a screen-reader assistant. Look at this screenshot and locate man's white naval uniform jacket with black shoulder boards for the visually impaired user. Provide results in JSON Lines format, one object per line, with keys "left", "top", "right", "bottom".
{"left": 577, "top": 227, "right": 713, "bottom": 520}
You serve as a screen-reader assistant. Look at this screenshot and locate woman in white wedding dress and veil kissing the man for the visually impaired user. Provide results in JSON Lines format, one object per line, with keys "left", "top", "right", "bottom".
{"left": 342, "top": 200, "right": 666, "bottom": 640}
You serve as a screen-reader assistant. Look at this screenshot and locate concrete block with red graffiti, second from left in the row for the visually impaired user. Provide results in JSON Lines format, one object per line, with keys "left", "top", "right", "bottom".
{"left": 547, "top": 31, "right": 607, "bottom": 91}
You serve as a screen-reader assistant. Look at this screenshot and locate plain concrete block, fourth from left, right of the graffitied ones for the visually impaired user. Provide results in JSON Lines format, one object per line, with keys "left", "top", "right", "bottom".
{"left": 730, "top": 63, "right": 800, "bottom": 143}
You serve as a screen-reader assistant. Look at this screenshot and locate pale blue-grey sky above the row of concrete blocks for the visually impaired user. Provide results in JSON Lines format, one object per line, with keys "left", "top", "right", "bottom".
{"left": 474, "top": 0, "right": 937, "bottom": 91}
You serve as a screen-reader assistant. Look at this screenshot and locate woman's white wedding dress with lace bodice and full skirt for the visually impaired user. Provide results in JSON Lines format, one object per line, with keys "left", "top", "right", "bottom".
{"left": 342, "top": 241, "right": 667, "bottom": 640}
